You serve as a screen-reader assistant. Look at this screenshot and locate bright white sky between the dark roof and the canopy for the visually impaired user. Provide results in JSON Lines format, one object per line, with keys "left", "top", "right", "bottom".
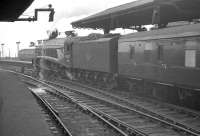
{"left": 0, "top": 0, "right": 134, "bottom": 56}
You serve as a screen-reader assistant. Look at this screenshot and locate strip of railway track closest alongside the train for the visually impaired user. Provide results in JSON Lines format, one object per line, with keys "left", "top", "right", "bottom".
{"left": 53, "top": 80, "right": 200, "bottom": 134}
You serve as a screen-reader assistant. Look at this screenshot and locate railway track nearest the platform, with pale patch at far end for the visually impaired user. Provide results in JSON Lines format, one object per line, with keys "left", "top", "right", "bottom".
{"left": 19, "top": 76, "right": 128, "bottom": 136}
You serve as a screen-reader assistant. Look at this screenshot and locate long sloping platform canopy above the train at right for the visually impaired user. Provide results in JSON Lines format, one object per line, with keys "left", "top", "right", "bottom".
{"left": 71, "top": 0, "right": 200, "bottom": 30}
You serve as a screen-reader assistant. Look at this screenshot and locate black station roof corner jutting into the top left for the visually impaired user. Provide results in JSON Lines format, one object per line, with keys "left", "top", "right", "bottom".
{"left": 0, "top": 0, "right": 34, "bottom": 22}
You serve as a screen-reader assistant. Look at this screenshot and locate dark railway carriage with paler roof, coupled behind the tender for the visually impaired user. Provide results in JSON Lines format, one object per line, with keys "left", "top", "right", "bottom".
{"left": 118, "top": 24, "right": 200, "bottom": 106}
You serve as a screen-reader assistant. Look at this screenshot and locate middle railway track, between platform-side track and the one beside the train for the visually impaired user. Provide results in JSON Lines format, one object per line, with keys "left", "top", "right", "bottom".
{"left": 41, "top": 78, "right": 199, "bottom": 136}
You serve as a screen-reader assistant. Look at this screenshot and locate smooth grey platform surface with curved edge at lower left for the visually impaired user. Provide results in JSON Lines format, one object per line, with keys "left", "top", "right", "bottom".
{"left": 0, "top": 70, "right": 52, "bottom": 136}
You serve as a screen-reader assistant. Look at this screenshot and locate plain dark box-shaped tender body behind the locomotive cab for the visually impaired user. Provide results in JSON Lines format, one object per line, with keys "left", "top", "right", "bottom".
{"left": 72, "top": 38, "right": 117, "bottom": 73}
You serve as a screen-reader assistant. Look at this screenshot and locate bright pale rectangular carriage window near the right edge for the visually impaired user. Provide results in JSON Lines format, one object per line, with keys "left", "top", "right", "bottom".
{"left": 185, "top": 50, "right": 196, "bottom": 67}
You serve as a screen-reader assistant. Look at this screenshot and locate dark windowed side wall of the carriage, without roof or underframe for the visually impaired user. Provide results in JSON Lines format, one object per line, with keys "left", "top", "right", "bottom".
{"left": 118, "top": 36, "right": 200, "bottom": 88}
